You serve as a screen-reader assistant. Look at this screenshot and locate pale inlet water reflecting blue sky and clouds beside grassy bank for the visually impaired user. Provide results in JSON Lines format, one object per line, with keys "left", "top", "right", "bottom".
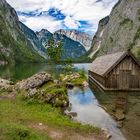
{"left": 67, "top": 87, "right": 125, "bottom": 140}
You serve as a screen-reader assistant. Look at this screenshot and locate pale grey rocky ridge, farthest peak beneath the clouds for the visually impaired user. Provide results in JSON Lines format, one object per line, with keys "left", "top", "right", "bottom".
{"left": 55, "top": 29, "right": 92, "bottom": 51}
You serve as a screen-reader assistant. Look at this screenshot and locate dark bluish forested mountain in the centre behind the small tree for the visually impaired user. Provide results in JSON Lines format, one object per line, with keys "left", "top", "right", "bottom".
{"left": 36, "top": 29, "right": 86, "bottom": 59}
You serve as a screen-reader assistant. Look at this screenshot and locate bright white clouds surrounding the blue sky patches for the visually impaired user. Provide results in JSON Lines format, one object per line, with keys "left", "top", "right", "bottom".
{"left": 7, "top": 0, "right": 118, "bottom": 32}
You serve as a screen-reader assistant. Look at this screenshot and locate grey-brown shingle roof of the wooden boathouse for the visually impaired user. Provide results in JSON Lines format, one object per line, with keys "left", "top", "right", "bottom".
{"left": 90, "top": 51, "right": 131, "bottom": 76}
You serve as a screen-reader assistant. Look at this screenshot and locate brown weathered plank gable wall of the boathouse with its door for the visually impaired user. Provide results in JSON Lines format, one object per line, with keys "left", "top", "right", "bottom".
{"left": 105, "top": 57, "right": 140, "bottom": 89}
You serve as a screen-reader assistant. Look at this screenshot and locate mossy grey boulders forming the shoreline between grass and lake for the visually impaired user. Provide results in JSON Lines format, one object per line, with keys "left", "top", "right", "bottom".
{"left": 0, "top": 72, "right": 87, "bottom": 107}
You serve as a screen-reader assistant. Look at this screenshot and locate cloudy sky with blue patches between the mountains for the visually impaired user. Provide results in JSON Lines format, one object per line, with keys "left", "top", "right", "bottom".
{"left": 7, "top": 0, "right": 118, "bottom": 34}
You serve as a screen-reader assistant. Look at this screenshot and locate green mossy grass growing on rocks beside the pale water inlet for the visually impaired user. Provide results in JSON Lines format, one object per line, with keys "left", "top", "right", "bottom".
{"left": 23, "top": 82, "right": 69, "bottom": 107}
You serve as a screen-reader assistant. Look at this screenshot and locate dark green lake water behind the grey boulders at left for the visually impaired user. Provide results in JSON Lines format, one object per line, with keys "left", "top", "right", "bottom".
{"left": 0, "top": 63, "right": 63, "bottom": 81}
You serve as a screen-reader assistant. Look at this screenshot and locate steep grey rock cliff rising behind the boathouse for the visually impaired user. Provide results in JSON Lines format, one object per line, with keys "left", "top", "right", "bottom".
{"left": 89, "top": 0, "right": 140, "bottom": 58}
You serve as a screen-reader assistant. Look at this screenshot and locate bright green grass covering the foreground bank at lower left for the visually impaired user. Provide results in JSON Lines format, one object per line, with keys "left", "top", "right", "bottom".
{"left": 0, "top": 96, "right": 100, "bottom": 140}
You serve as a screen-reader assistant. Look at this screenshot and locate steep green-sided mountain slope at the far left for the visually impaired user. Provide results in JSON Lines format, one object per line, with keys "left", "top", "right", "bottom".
{"left": 0, "top": 0, "right": 44, "bottom": 64}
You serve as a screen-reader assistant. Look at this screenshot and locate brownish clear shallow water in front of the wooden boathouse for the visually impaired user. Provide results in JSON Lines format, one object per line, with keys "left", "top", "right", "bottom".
{"left": 90, "top": 80, "right": 140, "bottom": 140}
